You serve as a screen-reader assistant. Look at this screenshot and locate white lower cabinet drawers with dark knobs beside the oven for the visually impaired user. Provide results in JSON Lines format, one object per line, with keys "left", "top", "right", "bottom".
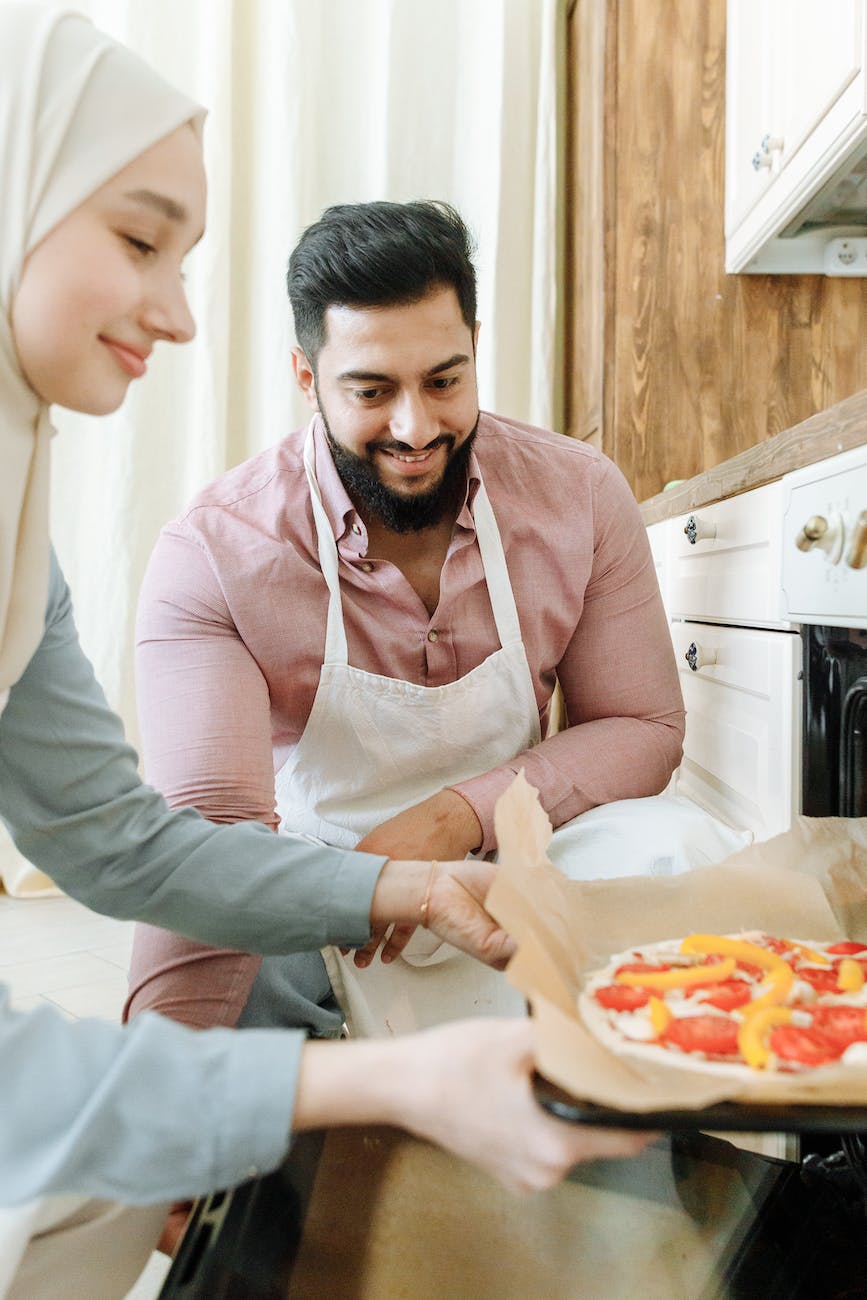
{"left": 651, "top": 482, "right": 802, "bottom": 840}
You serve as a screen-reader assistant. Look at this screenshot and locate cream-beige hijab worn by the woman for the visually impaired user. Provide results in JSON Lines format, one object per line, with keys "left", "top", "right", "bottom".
{"left": 0, "top": 3, "right": 204, "bottom": 709}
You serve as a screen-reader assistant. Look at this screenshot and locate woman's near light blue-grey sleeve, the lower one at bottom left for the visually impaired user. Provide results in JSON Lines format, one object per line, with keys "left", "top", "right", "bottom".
{"left": 0, "top": 985, "right": 304, "bottom": 1205}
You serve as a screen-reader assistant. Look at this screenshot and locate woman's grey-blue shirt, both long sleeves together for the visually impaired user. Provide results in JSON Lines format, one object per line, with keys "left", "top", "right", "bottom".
{"left": 0, "top": 556, "right": 383, "bottom": 1205}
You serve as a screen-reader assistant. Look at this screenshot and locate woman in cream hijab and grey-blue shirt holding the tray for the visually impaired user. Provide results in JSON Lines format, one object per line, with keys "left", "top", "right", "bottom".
{"left": 0, "top": 3, "right": 642, "bottom": 1300}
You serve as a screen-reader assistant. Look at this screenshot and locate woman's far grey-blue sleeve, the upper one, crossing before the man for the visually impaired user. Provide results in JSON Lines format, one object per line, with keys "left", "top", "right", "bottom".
{"left": 0, "top": 543, "right": 385, "bottom": 953}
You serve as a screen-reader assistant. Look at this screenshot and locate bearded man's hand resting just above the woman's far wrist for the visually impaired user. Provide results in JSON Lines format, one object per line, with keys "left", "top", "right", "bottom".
{"left": 356, "top": 790, "right": 484, "bottom": 862}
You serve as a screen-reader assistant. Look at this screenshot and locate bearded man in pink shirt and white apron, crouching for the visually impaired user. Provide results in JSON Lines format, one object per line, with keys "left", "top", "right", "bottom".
{"left": 130, "top": 203, "right": 740, "bottom": 1035}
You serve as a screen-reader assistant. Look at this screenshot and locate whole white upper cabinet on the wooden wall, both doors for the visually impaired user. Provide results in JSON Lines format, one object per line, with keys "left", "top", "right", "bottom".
{"left": 725, "top": 0, "right": 867, "bottom": 274}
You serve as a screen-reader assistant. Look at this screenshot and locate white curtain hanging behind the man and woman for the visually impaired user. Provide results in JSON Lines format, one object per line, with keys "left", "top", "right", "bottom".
{"left": 28, "top": 0, "right": 564, "bottom": 741}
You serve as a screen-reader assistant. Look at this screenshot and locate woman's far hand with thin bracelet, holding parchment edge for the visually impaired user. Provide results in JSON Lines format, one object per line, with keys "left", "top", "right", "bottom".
{"left": 355, "top": 858, "right": 515, "bottom": 970}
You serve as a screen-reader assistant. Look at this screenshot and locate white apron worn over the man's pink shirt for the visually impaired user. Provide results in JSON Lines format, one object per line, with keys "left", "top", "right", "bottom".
{"left": 276, "top": 432, "right": 541, "bottom": 1036}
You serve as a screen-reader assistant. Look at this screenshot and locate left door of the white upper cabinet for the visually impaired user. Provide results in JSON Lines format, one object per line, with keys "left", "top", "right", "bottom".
{"left": 725, "top": 0, "right": 780, "bottom": 235}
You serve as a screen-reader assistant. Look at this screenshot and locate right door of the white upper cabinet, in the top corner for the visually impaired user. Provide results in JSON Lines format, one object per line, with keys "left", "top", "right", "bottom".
{"left": 773, "top": 0, "right": 863, "bottom": 166}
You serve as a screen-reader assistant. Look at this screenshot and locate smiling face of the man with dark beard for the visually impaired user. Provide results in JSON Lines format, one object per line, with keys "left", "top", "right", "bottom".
{"left": 292, "top": 289, "right": 478, "bottom": 532}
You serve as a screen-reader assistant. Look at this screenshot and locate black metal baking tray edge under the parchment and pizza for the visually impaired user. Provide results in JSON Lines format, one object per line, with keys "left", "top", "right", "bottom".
{"left": 533, "top": 1074, "right": 867, "bottom": 1134}
